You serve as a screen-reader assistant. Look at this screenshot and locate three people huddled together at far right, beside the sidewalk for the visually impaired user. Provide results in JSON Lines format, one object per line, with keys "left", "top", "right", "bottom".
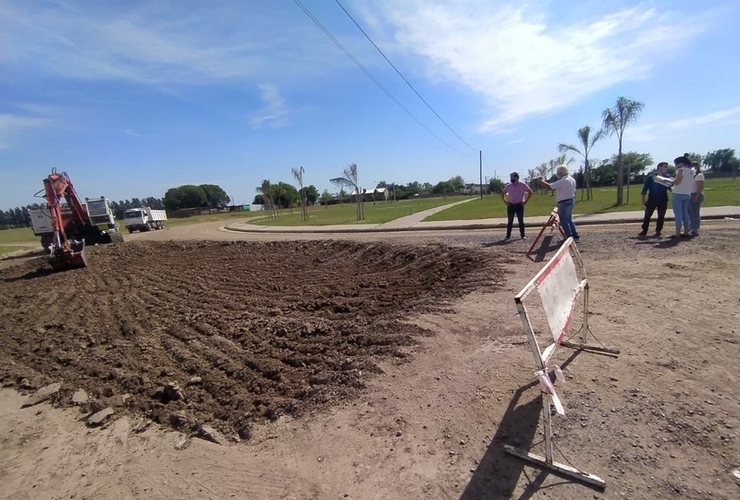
{"left": 638, "top": 155, "right": 704, "bottom": 238}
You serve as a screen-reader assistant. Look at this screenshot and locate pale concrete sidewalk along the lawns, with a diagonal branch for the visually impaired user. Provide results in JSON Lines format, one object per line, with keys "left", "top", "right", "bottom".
{"left": 225, "top": 203, "right": 740, "bottom": 233}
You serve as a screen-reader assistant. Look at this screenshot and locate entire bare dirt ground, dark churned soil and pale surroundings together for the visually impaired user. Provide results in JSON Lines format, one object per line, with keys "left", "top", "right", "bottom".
{"left": 0, "top": 221, "right": 740, "bottom": 500}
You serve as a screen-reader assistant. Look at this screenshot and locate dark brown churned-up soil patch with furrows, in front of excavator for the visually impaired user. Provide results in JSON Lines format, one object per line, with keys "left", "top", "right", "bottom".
{"left": 0, "top": 241, "right": 502, "bottom": 438}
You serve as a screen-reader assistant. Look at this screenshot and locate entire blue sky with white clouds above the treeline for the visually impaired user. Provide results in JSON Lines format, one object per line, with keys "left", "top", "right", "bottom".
{"left": 0, "top": 0, "right": 740, "bottom": 209}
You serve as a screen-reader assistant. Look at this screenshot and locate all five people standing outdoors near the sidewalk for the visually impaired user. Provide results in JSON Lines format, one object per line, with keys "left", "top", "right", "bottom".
{"left": 501, "top": 155, "right": 704, "bottom": 241}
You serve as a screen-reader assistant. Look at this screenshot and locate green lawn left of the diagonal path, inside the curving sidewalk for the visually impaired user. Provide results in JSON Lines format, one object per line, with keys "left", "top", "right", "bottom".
{"left": 254, "top": 196, "right": 469, "bottom": 227}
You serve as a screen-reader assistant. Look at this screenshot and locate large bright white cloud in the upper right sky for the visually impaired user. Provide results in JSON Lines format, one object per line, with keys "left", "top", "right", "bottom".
{"left": 372, "top": 0, "right": 707, "bottom": 131}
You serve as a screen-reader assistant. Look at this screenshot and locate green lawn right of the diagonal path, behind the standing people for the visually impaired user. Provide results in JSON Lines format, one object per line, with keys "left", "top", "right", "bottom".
{"left": 425, "top": 178, "right": 740, "bottom": 221}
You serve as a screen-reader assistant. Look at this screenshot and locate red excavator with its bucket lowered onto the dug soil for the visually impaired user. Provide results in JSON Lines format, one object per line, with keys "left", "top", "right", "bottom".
{"left": 32, "top": 169, "right": 123, "bottom": 271}
